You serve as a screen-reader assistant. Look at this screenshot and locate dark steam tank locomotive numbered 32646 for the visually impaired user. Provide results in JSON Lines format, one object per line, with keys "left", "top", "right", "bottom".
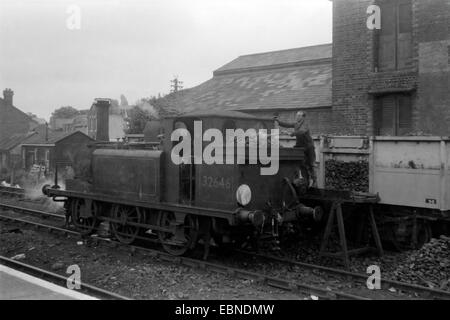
{"left": 43, "top": 112, "right": 321, "bottom": 255}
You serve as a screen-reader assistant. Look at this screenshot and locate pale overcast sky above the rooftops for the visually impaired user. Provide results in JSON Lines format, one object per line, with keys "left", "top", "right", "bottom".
{"left": 0, "top": 0, "right": 332, "bottom": 118}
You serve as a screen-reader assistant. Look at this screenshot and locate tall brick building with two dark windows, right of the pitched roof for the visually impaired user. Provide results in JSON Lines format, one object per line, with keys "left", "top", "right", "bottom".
{"left": 333, "top": 0, "right": 450, "bottom": 135}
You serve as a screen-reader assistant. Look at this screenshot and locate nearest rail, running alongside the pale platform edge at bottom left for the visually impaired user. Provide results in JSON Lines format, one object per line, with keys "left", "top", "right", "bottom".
{"left": 0, "top": 256, "right": 130, "bottom": 300}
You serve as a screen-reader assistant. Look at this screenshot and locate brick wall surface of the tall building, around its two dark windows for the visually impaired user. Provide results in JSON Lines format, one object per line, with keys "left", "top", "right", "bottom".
{"left": 333, "top": 0, "right": 450, "bottom": 135}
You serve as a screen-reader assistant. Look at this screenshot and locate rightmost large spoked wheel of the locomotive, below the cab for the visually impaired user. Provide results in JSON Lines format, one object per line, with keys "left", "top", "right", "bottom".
{"left": 158, "top": 211, "right": 198, "bottom": 256}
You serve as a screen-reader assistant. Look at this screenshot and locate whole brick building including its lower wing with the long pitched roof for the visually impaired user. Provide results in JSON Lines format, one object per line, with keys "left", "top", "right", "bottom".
{"left": 158, "top": 0, "right": 450, "bottom": 136}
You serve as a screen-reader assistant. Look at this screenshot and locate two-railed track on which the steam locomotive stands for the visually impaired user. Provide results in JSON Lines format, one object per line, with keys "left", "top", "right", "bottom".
{"left": 0, "top": 204, "right": 450, "bottom": 300}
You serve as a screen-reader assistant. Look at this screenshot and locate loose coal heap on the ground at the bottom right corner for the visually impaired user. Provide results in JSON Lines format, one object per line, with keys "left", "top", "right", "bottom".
{"left": 394, "top": 236, "right": 450, "bottom": 291}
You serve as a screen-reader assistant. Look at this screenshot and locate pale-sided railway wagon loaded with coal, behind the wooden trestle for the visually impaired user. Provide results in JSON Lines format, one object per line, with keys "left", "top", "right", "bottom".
{"left": 315, "top": 136, "right": 450, "bottom": 249}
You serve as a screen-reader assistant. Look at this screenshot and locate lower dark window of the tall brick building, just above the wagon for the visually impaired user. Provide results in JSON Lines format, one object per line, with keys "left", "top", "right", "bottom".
{"left": 374, "top": 94, "right": 412, "bottom": 136}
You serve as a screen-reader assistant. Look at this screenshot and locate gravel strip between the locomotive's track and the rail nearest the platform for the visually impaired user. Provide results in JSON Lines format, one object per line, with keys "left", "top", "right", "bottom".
{"left": 0, "top": 222, "right": 311, "bottom": 300}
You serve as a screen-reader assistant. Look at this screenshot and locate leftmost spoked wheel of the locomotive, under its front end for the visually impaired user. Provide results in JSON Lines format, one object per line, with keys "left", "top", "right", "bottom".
{"left": 70, "top": 199, "right": 99, "bottom": 235}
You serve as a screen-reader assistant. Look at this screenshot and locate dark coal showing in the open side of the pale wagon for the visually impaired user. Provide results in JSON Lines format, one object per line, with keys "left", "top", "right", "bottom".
{"left": 325, "top": 159, "right": 369, "bottom": 192}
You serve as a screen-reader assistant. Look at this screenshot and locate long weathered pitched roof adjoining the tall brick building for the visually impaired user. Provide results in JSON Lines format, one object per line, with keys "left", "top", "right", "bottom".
{"left": 163, "top": 45, "right": 332, "bottom": 113}
